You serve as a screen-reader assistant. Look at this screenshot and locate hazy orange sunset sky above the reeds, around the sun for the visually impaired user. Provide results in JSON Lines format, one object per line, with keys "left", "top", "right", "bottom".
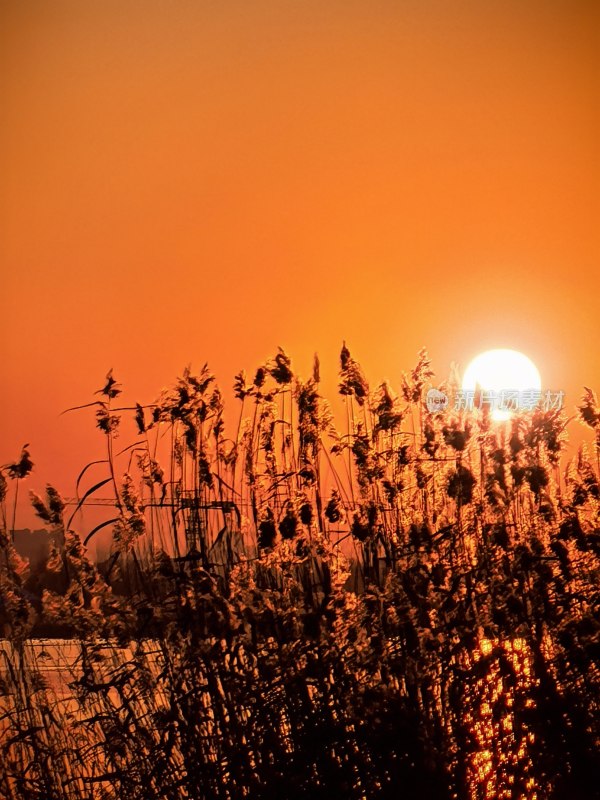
{"left": 0, "top": 0, "right": 600, "bottom": 524}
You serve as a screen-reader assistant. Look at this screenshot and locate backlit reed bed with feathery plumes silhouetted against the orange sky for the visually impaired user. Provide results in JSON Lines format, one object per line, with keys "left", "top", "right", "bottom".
{"left": 0, "top": 345, "right": 600, "bottom": 800}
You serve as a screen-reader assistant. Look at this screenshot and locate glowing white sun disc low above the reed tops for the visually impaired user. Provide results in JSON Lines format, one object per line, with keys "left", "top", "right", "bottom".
{"left": 462, "top": 350, "right": 542, "bottom": 421}
